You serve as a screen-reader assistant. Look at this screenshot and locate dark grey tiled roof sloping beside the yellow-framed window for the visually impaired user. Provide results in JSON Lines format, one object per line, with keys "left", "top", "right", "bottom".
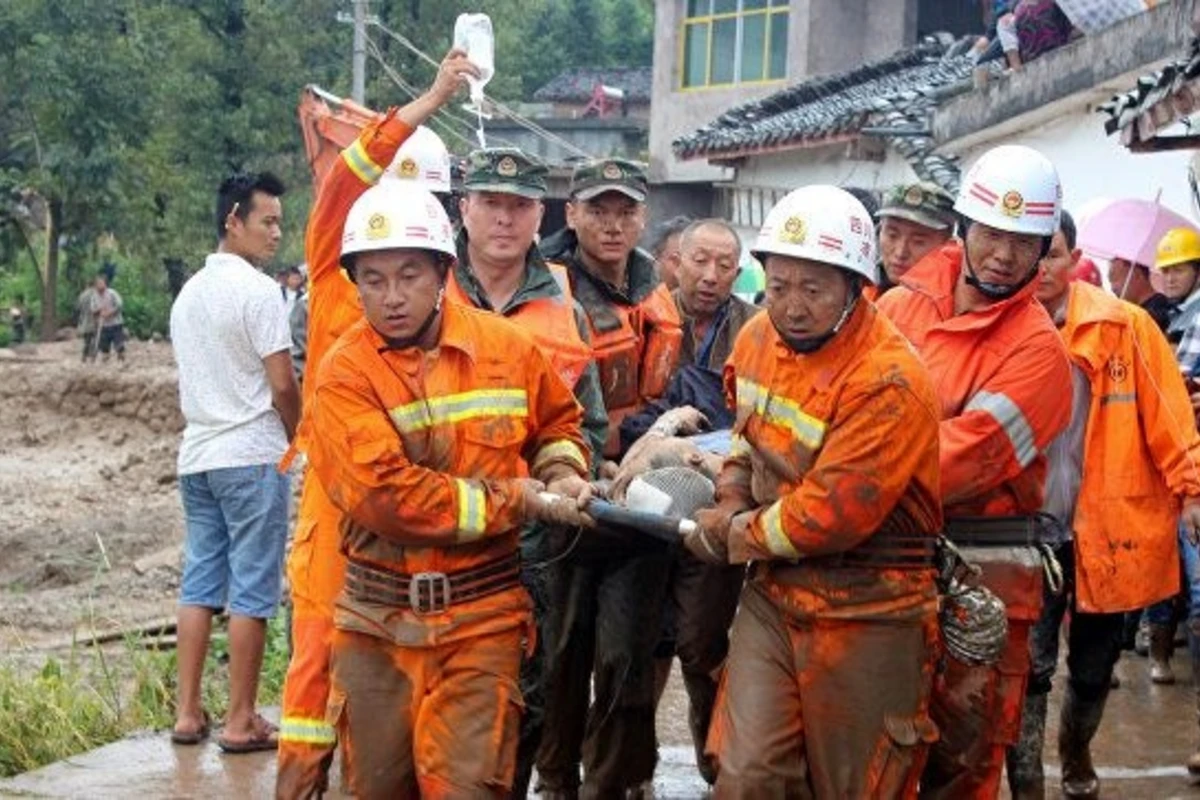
{"left": 672, "top": 34, "right": 1000, "bottom": 190}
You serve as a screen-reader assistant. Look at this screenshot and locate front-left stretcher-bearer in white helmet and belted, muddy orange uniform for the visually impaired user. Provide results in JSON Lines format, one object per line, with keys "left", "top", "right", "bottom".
{"left": 308, "top": 184, "right": 590, "bottom": 798}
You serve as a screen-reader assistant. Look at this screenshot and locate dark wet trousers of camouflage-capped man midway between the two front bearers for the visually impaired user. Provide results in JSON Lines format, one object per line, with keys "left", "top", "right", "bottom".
{"left": 538, "top": 549, "right": 671, "bottom": 798}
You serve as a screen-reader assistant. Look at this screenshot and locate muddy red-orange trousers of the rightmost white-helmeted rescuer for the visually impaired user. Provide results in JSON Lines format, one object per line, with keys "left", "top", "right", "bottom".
{"left": 920, "top": 575, "right": 1042, "bottom": 800}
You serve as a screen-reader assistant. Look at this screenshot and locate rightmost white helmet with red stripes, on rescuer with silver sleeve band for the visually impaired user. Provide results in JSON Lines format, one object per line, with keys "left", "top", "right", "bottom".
{"left": 954, "top": 144, "right": 1062, "bottom": 237}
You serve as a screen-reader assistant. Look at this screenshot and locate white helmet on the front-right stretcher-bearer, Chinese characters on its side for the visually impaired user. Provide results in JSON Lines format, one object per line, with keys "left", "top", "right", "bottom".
{"left": 750, "top": 186, "right": 878, "bottom": 283}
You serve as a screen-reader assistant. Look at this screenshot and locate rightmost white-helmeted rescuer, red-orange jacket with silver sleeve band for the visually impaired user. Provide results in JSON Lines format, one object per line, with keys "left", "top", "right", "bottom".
{"left": 878, "top": 145, "right": 1072, "bottom": 800}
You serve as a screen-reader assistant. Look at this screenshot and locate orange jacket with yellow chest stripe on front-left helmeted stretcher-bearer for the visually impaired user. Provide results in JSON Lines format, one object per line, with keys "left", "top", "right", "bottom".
{"left": 310, "top": 303, "right": 588, "bottom": 644}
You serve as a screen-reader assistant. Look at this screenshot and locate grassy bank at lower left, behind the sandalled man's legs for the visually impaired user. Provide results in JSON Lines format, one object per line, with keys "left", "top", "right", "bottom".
{"left": 0, "top": 614, "right": 288, "bottom": 777}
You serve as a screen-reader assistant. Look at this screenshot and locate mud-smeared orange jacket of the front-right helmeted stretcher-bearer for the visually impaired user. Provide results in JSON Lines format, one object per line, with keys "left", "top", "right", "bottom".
{"left": 720, "top": 302, "right": 942, "bottom": 560}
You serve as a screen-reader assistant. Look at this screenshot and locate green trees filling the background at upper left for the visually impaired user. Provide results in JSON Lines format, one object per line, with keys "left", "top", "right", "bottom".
{"left": 0, "top": 0, "right": 653, "bottom": 336}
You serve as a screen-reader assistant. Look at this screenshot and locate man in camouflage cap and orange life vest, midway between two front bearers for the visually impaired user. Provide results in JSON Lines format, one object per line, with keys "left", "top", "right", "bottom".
{"left": 538, "top": 158, "right": 683, "bottom": 798}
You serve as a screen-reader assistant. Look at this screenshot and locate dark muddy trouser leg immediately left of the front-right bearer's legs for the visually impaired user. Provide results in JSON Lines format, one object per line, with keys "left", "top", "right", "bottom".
{"left": 660, "top": 548, "right": 745, "bottom": 783}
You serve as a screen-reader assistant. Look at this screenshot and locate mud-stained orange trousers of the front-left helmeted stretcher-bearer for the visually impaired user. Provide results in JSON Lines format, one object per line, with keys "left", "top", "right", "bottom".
{"left": 329, "top": 626, "right": 523, "bottom": 800}
